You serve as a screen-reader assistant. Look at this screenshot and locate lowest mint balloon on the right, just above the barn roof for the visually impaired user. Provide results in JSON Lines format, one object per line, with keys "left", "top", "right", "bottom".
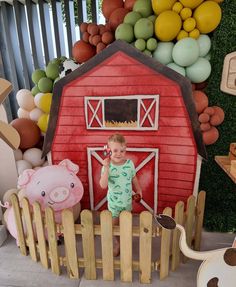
{"left": 186, "top": 57, "right": 211, "bottom": 83}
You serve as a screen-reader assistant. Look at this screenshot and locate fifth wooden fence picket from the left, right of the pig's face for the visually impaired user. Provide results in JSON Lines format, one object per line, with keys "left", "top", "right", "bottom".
{"left": 62, "top": 209, "right": 79, "bottom": 278}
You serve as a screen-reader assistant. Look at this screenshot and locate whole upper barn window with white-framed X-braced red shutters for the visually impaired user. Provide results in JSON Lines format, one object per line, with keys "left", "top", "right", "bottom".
{"left": 85, "top": 95, "right": 159, "bottom": 130}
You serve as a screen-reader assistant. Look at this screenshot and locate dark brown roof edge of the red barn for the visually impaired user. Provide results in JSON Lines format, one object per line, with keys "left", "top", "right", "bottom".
{"left": 43, "top": 40, "right": 207, "bottom": 159}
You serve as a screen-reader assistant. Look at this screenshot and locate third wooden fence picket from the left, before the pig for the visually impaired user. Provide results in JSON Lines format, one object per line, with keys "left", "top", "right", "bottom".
{"left": 33, "top": 202, "right": 48, "bottom": 269}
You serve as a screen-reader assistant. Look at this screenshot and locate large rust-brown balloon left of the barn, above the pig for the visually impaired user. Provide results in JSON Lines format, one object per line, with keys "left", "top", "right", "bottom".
{"left": 11, "top": 119, "right": 40, "bottom": 149}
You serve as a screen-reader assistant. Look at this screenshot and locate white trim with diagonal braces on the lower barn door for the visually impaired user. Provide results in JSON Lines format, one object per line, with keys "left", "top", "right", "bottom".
{"left": 87, "top": 147, "right": 159, "bottom": 214}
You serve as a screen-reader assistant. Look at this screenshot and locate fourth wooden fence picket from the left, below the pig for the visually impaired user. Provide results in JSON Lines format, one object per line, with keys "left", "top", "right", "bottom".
{"left": 45, "top": 207, "right": 60, "bottom": 275}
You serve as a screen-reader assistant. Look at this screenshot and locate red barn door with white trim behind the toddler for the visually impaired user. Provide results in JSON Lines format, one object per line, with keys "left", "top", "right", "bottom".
{"left": 87, "top": 147, "right": 158, "bottom": 213}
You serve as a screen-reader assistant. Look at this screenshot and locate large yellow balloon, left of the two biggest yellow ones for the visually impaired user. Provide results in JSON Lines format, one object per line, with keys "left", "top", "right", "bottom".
{"left": 155, "top": 10, "right": 182, "bottom": 42}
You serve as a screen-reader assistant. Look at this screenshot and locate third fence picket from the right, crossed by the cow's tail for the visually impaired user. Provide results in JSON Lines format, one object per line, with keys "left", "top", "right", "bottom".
{"left": 171, "top": 201, "right": 184, "bottom": 271}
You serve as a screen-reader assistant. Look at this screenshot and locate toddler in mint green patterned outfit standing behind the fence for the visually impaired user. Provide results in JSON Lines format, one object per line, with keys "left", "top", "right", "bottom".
{"left": 100, "top": 134, "right": 142, "bottom": 256}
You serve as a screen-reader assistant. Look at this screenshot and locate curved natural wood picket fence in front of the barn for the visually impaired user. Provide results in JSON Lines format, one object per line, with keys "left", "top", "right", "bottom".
{"left": 11, "top": 191, "right": 205, "bottom": 283}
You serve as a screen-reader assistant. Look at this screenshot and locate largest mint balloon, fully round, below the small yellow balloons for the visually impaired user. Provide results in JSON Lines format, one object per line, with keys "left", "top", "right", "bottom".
{"left": 172, "top": 37, "right": 199, "bottom": 67}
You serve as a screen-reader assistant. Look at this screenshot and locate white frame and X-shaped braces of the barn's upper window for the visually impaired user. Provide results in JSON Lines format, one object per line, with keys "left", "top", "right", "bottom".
{"left": 84, "top": 95, "right": 159, "bottom": 131}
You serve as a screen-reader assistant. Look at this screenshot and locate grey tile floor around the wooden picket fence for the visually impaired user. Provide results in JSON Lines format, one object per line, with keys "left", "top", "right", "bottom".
{"left": 0, "top": 232, "right": 235, "bottom": 287}
